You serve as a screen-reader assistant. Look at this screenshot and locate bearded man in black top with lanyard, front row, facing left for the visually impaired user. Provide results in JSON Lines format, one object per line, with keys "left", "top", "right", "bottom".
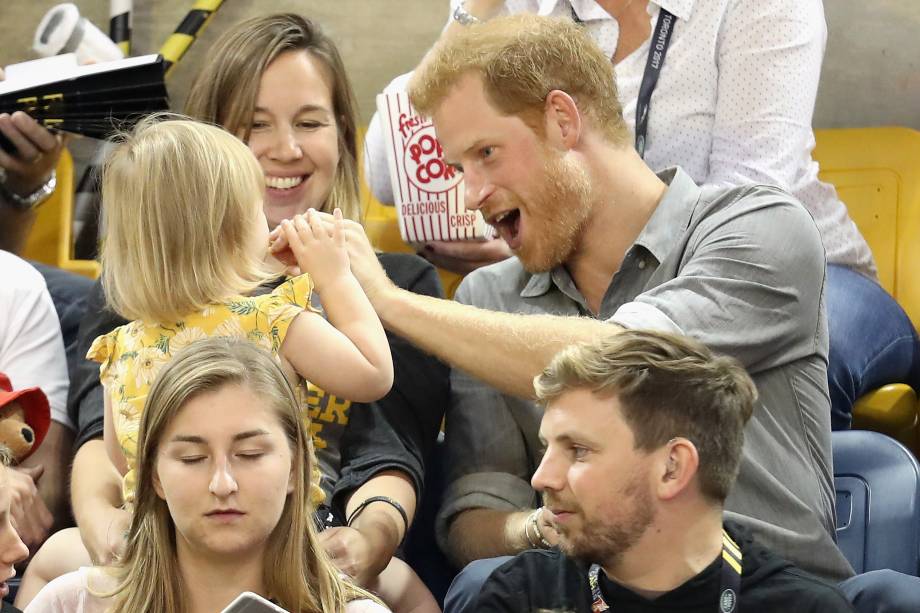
{"left": 474, "top": 330, "right": 853, "bottom": 613}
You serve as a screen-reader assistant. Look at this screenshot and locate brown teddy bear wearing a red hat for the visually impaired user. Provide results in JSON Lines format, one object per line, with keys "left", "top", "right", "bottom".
{"left": 0, "top": 373, "right": 51, "bottom": 464}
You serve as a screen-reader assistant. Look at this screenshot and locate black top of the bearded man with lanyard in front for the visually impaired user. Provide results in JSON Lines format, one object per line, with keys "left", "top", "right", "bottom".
{"left": 473, "top": 522, "right": 854, "bottom": 613}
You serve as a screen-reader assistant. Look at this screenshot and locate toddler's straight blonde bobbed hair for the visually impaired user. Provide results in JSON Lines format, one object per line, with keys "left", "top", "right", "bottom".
{"left": 102, "top": 114, "right": 277, "bottom": 322}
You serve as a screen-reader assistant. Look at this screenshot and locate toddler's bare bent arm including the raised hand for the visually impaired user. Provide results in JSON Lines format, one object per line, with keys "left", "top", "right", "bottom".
{"left": 281, "top": 210, "right": 393, "bottom": 402}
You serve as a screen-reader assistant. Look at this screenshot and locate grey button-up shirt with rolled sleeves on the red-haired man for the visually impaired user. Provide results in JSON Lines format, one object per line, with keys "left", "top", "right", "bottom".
{"left": 438, "top": 168, "right": 853, "bottom": 580}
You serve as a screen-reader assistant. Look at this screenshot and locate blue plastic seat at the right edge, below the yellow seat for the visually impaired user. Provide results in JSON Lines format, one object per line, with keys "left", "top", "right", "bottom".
{"left": 831, "top": 430, "right": 920, "bottom": 576}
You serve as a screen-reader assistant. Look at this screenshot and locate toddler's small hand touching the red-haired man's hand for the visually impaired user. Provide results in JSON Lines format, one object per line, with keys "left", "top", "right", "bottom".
{"left": 272, "top": 209, "right": 351, "bottom": 294}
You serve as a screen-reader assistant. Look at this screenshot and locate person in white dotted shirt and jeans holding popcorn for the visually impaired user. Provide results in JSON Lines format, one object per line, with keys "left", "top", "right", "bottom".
{"left": 365, "top": 0, "right": 920, "bottom": 430}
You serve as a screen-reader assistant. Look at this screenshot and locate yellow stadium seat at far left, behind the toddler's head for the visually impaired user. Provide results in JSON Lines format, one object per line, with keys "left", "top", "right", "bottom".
{"left": 22, "top": 149, "right": 99, "bottom": 279}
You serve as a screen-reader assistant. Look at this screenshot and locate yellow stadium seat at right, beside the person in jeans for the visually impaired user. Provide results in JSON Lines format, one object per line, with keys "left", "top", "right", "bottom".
{"left": 814, "top": 128, "right": 920, "bottom": 453}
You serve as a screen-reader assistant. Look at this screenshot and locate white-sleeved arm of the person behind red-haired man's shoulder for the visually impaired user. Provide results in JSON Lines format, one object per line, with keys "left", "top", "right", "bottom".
{"left": 701, "top": 0, "right": 827, "bottom": 190}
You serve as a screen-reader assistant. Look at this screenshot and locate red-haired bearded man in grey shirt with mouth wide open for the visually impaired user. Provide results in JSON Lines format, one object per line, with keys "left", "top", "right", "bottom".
{"left": 310, "top": 10, "right": 920, "bottom": 609}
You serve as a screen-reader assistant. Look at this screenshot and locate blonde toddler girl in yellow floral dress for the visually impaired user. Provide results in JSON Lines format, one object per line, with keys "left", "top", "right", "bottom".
{"left": 87, "top": 116, "right": 393, "bottom": 503}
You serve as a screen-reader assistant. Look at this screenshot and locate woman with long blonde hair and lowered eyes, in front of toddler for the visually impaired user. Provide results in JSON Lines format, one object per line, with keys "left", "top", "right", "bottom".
{"left": 25, "top": 337, "right": 387, "bottom": 613}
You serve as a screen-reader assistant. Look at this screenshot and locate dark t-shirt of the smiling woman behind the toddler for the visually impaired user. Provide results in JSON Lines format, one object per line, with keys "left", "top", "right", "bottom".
{"left": 67, "top": 253, "right": 450, "bottom": 524}
